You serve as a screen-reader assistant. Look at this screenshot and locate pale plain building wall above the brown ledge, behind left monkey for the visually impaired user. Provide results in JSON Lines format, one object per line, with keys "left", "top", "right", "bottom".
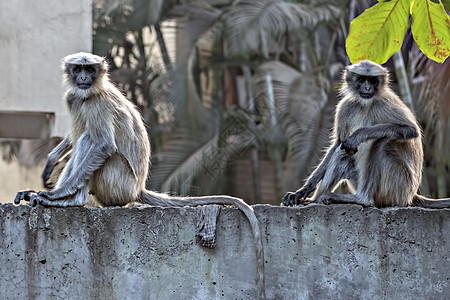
{"left": 0, "top": 0, "right": 92, "bottom": 136}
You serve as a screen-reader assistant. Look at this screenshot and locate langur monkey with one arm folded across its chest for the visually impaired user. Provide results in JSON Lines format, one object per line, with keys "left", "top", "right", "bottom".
{"left": 282, "top": 60, "right": 450, "bottom": 208}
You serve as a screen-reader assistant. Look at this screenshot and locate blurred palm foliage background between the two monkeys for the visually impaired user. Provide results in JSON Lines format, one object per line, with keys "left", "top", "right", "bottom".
{"left": 89, "top": 0, "right": 449, "bottom": 204}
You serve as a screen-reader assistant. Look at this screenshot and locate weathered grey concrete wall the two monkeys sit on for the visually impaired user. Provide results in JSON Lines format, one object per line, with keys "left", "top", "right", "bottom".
{"left": 0, "top": 204, "right": 450, "bottom": 299}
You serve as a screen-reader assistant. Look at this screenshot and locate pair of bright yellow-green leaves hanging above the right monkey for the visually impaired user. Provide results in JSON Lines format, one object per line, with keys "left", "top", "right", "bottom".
{"left": 346, "top": 0, "right": 450, "bottom": 64}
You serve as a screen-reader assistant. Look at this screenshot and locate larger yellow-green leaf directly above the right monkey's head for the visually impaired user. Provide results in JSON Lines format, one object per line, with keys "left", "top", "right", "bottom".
{"left": 345, "top": 0, "right": 410, "bottom": 64}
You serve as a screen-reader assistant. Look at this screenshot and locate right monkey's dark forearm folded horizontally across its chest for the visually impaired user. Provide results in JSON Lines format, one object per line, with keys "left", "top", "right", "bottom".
{"left": 341, "top": 124, "right": 419, "bottom": 155}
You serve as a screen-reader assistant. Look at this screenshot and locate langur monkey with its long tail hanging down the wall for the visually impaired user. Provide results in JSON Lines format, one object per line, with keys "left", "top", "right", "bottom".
{"left": 14, "top": 53, "right": 265, "bottom": 298}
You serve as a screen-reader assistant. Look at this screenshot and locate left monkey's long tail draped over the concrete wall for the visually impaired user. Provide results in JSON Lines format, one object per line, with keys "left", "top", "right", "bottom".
{"left": 139, "top": 190, "right": 266, "bottom": 300}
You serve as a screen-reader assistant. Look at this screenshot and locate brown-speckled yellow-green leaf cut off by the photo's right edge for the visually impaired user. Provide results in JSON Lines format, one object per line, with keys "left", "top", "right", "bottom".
{"left": 411, "top": 0, "right": 450, "bottom": 63}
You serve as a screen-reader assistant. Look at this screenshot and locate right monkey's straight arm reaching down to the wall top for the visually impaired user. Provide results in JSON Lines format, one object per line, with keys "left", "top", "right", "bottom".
{"left": 282, "top": 140, "right": 341, "bottom": 206}
